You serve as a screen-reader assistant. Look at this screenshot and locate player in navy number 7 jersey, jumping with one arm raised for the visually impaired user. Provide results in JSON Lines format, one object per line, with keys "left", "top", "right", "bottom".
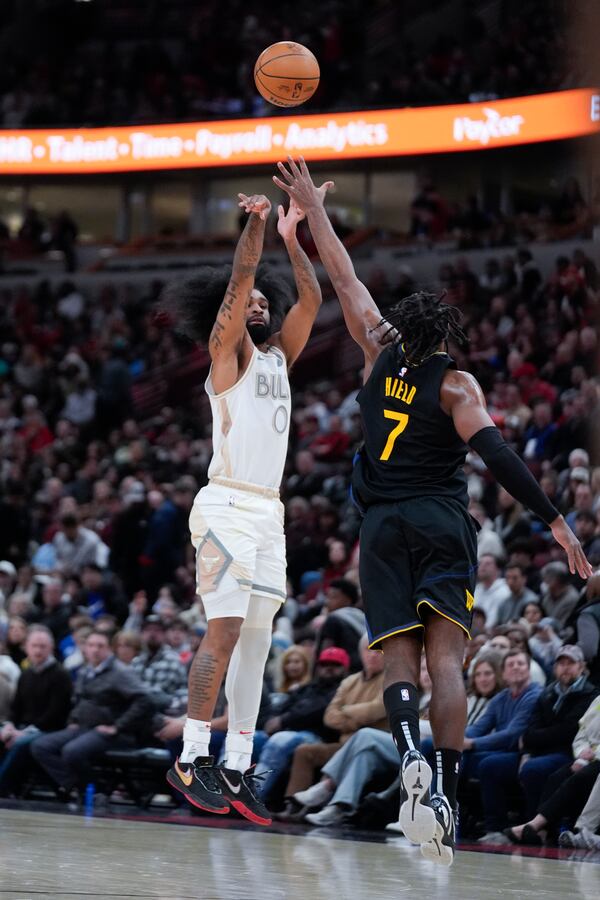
{"left": 273, "top": 157, "right": 592, "bottom": 865}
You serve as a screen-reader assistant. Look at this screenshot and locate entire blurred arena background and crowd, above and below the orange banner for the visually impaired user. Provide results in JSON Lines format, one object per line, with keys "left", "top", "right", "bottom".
{"left": 0, "top": 0, "right": 600, "bottom": 850}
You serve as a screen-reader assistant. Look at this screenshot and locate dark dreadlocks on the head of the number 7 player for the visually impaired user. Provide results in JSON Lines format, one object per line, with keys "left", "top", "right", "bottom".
{"left": 373, "top": 291, "right": 468, "bottom": 366}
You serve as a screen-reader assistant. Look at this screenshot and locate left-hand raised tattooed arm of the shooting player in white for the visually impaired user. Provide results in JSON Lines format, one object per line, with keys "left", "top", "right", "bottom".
{"left": 208, "top": 194, "right": 271, "bottom": 394}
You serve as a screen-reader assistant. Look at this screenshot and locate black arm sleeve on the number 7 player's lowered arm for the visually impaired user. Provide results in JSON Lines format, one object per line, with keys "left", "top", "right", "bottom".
{"left": 469, "top": 425, "right": 560, "bottom": 525}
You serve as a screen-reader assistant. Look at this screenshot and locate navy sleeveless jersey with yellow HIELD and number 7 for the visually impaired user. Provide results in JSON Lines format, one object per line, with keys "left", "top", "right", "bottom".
{"left": 352, "top": 346, "right": 468, "bottom": 507}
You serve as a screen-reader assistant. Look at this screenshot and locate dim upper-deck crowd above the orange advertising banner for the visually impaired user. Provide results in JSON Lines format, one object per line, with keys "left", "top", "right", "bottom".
{"left": 0, "top": 0, "right": 584, "bottom": 129}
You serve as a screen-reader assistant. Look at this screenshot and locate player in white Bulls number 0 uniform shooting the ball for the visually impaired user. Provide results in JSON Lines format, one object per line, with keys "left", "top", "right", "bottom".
{"left": 162, "top": 194, "right": 321, "bottom": 825}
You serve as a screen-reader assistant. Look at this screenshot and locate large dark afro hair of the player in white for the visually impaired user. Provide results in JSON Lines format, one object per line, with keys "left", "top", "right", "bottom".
{"left": 158, "top": 263, "right": 292, "bottom": 345}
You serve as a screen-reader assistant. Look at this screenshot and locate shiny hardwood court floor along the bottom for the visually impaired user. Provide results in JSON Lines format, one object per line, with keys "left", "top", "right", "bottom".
{"left": 0, "top": 809, "right": 600, "bottom": 900}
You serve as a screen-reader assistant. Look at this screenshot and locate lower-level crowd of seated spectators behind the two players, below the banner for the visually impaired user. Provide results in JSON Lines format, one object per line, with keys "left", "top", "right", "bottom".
{"left": 0, "top": 236, "right": 600, "bottom": 844}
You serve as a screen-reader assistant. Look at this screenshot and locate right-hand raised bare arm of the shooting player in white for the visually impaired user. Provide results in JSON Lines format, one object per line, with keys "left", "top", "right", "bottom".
{"left": 272, "top": 199, "right": 321, "bottom": 366}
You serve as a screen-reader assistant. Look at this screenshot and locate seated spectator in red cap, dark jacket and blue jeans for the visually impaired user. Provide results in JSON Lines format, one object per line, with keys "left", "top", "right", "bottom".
{"left": 255, "top": 647, "right": 350, "bottom": 802}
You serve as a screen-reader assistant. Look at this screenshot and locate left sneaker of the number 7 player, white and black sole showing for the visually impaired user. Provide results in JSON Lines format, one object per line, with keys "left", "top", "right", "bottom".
{"left": 398, "top": 750, "right": 436, "bottom": 844}
